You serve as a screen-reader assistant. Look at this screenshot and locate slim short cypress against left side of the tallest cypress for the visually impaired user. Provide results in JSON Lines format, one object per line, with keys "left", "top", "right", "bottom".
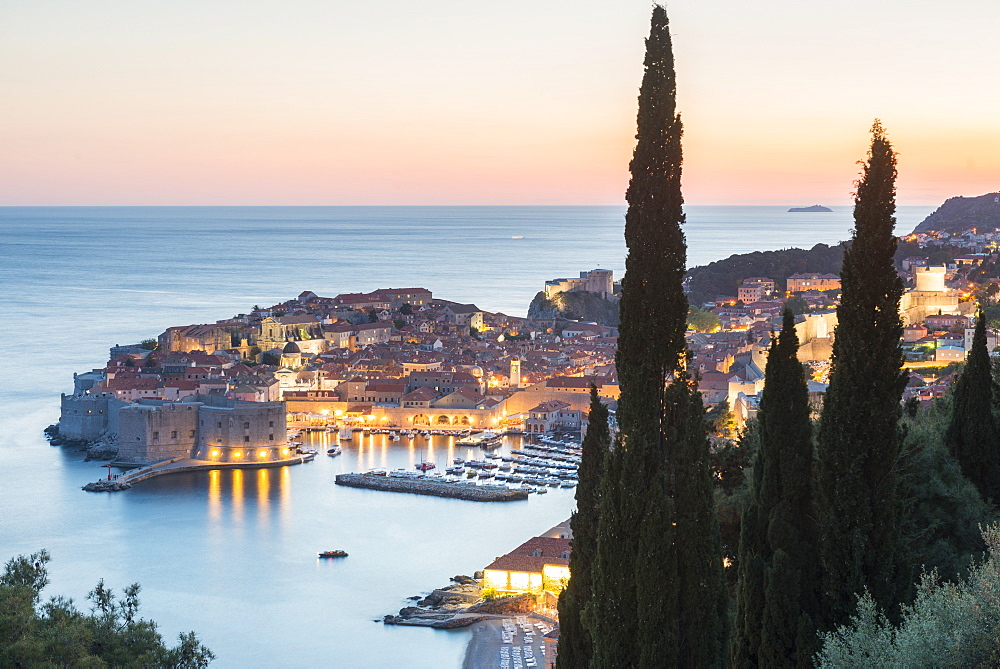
{"left": 556, "top": 384, "right": 611, "bottom": 669}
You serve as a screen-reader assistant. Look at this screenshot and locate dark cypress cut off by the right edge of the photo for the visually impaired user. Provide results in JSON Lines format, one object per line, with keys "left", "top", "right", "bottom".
{"left": 945, "top": 310, "right": 1000, "bottom": 503}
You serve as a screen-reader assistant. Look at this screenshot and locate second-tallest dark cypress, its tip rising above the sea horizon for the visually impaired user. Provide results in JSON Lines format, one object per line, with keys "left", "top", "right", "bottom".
{"left": 815, "top": 120, "right": 906, "bottom": 630}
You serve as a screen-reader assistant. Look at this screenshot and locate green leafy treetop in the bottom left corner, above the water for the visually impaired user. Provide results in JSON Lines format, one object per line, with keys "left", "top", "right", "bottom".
{"left": 0, "top": 550, "right": 215, "bottom": 669}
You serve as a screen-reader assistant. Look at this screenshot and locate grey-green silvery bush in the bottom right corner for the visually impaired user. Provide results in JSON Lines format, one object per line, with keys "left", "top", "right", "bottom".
{"left": 816, "top": 526, "right": 1000, "bottom": 669}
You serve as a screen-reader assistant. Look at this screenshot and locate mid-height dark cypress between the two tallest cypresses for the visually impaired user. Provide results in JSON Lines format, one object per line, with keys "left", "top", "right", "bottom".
{"left": 731, "top": 309, "right": 820, "bottom": 667}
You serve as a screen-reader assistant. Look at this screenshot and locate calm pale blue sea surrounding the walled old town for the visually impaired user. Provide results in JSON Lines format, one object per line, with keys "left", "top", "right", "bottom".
{"left": 0, "top": 206, "right": 932, "bottom": 667}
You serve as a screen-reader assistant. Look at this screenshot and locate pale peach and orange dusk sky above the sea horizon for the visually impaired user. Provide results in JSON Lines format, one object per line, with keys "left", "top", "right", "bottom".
{"left": 0, "top": 0, "right": 1000, "bottom": 206}
